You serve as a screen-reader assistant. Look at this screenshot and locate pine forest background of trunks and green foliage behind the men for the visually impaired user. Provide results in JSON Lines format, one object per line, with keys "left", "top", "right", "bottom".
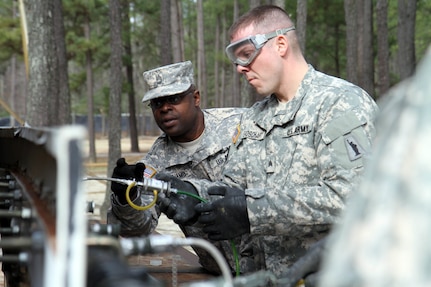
{"left": 0, "top": 0, "right": 431, "bottom": 214}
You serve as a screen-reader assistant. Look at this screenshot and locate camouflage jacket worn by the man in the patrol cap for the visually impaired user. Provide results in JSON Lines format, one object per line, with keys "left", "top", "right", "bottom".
{"left": 110, "top": 108, "right": 254, "bottom": 273}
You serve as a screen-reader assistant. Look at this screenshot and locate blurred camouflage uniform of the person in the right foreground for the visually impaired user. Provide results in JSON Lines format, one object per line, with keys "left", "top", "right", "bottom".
{"left": 319, "top": 49, "right": 431, "bottom": 287}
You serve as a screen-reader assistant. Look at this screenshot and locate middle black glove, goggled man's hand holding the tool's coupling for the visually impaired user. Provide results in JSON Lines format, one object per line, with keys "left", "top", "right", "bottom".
{"left": 156, "top": 173, "right": 200, "bottom": 225}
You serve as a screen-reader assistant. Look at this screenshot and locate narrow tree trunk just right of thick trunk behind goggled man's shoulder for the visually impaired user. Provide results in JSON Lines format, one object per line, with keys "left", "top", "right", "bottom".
{"left": 376, "top": 0, "right": 390, "bottom": 98}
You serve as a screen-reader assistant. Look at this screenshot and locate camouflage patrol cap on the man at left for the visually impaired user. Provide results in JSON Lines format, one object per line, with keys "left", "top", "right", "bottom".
{"left": 142, "top": 61, "right": 193, "bottom": 102}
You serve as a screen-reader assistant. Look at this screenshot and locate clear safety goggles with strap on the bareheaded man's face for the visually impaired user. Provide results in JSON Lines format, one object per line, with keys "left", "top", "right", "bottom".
{"left": 226, "top": 26, "right": 295, "bottom": 67}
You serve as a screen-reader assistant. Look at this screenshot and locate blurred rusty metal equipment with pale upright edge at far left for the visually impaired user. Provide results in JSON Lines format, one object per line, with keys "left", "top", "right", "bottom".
{"left": 0, "top": 126, "right": 87, "bottom": 286}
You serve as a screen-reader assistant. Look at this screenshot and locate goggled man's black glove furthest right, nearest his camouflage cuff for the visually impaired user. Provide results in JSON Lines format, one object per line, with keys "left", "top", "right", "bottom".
{"left": 195, "top": 186, "right": 250, "bottom": 240}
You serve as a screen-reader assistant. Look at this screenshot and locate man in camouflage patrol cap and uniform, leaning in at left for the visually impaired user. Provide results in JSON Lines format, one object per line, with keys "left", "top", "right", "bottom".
{"left": 109, "top": 61, "right": 254, "bottom": 273}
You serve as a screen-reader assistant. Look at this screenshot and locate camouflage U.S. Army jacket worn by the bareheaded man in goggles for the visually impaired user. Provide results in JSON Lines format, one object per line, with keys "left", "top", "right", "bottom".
{"left": 190, "top": 66, "right": 378, "bottom": 276}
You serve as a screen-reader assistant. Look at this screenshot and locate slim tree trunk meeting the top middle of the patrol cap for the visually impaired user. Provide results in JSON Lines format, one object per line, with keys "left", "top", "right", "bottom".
{"left": 160, "top": 0, "right": 172, "bottom": 66}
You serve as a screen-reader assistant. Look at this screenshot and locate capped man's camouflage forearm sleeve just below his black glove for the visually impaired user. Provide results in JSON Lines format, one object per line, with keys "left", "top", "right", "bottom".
{"left": 108, "top": 191, "right": 160, "bottom": 237}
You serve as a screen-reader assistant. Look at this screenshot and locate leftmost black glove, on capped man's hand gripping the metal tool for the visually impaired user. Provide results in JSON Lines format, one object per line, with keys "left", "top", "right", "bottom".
{"left": 111, "top": 158, "right": 145, "bottom": 204}
